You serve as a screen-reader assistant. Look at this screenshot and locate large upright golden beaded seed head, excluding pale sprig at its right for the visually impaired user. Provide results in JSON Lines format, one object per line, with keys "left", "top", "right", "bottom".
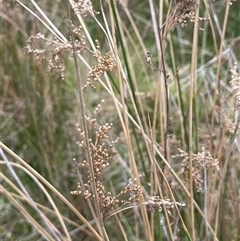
{"left": 71, "top": 101, "right": 143, "bottom": 220}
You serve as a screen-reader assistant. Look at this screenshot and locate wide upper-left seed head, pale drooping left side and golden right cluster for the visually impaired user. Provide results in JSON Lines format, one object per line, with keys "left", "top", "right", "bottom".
{"left": 25, "top": 21, "right": 117, "bottom": 84}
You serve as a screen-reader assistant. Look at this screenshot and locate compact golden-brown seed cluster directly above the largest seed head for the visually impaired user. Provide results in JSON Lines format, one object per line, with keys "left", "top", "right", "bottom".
{"left": 83, "top": 40, "right": 117, "bottom": 89}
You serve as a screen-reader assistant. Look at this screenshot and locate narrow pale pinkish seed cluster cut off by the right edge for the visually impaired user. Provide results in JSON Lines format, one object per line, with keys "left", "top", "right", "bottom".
{"left": 230, "top": 63, "right": 240, "bottom": 110}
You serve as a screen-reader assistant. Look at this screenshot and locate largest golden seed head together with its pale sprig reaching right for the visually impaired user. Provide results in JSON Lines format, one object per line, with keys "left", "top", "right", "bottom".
{"left": 71, "top": 100, "right": 185, "bottom": 221}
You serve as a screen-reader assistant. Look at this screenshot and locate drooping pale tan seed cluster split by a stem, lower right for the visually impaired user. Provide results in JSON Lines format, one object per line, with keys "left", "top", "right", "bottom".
{"left": 172, "top": 147, "right": 220, "bottom": 191}
